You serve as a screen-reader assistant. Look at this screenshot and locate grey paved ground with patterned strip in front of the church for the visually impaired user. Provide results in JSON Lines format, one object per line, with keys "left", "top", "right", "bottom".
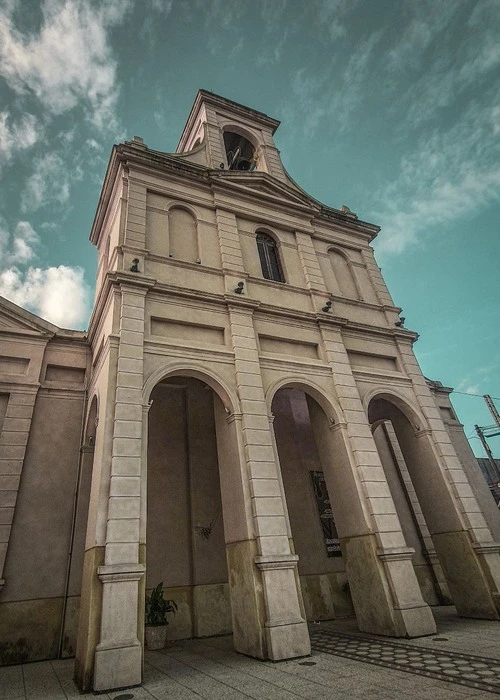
{"left": 0, "top": 608, "right": 500, "bottom": 700}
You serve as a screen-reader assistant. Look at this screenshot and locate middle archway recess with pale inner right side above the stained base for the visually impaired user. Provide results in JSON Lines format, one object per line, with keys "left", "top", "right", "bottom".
{"left": 266, "top": 377, "right": 369, "bottom": 622}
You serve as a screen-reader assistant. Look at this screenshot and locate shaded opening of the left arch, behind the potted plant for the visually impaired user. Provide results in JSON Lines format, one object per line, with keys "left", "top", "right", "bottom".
{"left": 146, "top": 376, "right": 232, "bottom": 639}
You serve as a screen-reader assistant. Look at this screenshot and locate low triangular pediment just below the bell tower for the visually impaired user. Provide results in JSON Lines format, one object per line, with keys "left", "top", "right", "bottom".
{"left": 209, "top": 170, "right": 318, "bottom": 209}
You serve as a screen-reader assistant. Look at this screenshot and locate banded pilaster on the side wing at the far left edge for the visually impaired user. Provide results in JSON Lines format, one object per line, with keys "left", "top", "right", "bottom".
{"left": 0, "top": 385, "right": 38, "bottom": 592}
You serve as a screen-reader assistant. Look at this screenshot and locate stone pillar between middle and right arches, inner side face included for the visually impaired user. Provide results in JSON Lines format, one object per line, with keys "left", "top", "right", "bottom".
{"left": 318, "top": 322, "right": 436, "bottom": 637}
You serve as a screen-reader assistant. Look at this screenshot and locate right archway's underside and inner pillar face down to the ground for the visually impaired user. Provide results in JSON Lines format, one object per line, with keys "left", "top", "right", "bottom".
{"left": 367, "top": 392, "right": 498, "bottom": 619}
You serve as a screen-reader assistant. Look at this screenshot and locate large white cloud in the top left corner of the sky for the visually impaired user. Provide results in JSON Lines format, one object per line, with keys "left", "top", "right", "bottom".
{"left": 0, "top": 0, "right": 131, "bottom": 130}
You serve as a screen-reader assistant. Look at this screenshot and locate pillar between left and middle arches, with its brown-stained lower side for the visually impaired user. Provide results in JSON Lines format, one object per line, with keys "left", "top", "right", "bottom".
{"left": 226, "top": 302, "right": 310, "bottom": 661}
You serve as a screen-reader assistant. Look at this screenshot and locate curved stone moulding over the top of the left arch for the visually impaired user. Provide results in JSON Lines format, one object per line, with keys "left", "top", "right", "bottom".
{"left": 142, "top": 362, "right": 240, "bottom": 414}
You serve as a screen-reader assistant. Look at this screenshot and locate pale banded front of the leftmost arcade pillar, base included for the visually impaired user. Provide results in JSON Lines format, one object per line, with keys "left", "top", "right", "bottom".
{"left": 93, "top": 283, "right": 147, "bottom": 691}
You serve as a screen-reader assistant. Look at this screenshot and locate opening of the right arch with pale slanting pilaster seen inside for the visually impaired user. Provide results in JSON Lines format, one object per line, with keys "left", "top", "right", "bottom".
{"left": 368, "top": 394, "right": 463, "bottom": 605}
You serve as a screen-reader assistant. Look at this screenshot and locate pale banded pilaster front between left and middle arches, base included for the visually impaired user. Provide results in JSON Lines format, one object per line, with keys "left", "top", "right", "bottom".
{"left": 229, "top": 305, "right": 311, "bottom": 660}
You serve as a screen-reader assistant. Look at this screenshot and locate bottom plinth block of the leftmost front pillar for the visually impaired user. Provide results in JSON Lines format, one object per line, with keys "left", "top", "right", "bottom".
{"left": 93, "top": 639, "right": 142, "bottom": 692}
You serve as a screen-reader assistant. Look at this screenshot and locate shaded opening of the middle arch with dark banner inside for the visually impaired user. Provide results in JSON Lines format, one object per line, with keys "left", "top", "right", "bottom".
{"left": 272, "top": 386, "right": 354, "bottom": 620}
